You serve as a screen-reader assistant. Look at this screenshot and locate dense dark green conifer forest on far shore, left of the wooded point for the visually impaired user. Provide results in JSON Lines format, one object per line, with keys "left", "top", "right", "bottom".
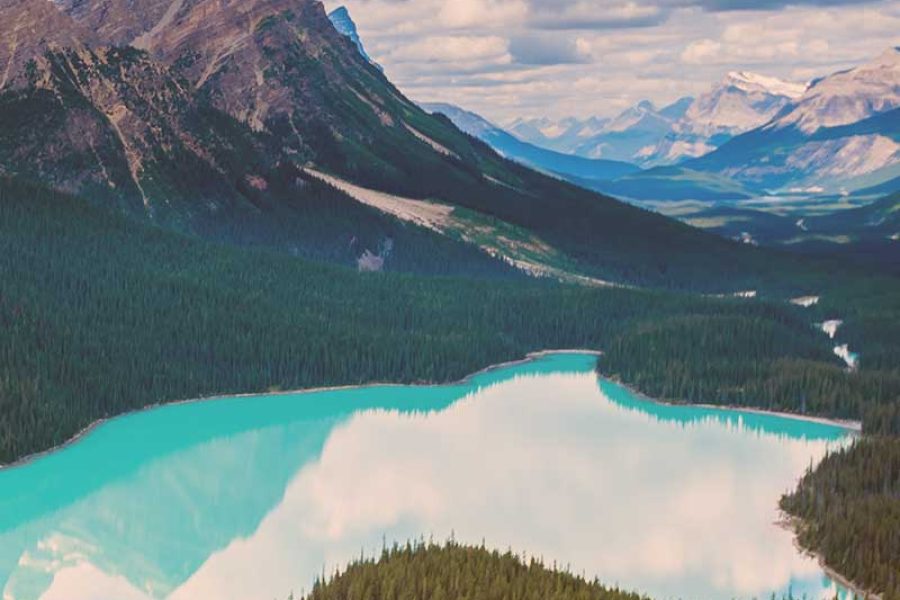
{"left": 0, "top": 176, "right": 888, "bottom": 462}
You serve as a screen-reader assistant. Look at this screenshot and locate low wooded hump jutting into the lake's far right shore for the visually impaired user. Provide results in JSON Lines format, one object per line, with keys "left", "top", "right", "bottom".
{"left": 599, "top": 314, "right": 900, "bottom": 434}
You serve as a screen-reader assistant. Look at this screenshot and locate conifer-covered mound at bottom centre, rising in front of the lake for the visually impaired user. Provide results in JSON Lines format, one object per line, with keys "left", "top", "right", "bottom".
{"left": 303, "top": 541, "right": 643, "bottom": 600}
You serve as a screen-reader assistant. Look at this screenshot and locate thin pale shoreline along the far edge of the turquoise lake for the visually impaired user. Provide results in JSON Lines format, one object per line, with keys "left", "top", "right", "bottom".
{"left": 0, "top": 348, "right": 862, "bottom": 473}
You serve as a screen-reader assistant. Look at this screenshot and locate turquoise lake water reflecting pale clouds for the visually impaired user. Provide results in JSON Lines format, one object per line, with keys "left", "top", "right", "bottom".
{"left": 0, "top": 354, "right": 850, "bottom": 600}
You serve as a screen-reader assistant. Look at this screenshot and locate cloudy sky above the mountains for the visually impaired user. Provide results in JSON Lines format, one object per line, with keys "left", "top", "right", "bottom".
{"left": 324, "top": 0, "right": 900, "bottom": 124}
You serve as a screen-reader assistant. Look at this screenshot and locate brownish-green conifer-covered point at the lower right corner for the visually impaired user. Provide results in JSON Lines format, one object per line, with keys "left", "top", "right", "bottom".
{"left": 781, "top": 437, "right": 900, "bottom": 600}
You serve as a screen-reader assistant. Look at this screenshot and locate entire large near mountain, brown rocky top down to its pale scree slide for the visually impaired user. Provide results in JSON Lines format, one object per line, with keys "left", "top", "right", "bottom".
{"left": 0, "top": 0, "right": 804, "bottom": 290}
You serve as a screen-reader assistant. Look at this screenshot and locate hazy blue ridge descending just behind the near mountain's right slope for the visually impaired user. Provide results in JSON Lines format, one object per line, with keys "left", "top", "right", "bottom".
{"left": 422, "top": 103, "right": 640, "bottom": 183}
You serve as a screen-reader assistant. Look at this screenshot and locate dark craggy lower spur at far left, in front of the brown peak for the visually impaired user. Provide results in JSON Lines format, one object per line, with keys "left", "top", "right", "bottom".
{"left": 0, "top": 47, "right": 274, "bottom": 220}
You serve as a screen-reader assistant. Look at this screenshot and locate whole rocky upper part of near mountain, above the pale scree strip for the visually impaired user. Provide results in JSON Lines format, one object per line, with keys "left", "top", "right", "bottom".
{"left": 0, "top": 0, "right": 480, "bottom": 221}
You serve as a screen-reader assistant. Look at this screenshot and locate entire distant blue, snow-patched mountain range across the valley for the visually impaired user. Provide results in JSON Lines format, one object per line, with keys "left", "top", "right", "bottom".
{"left": 440, "top": 48, "right": 900, "bottom": 200}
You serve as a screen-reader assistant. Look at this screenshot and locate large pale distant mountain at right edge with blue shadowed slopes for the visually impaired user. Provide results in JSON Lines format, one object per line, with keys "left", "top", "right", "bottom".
{"left": 685, "top": 48, "right": 900, "bottom": 192}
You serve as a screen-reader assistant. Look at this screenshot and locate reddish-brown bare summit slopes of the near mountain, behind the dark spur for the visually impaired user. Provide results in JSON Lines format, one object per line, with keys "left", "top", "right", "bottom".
{"left": 50, "top": 0, "right": 380, "bottom": 131}
